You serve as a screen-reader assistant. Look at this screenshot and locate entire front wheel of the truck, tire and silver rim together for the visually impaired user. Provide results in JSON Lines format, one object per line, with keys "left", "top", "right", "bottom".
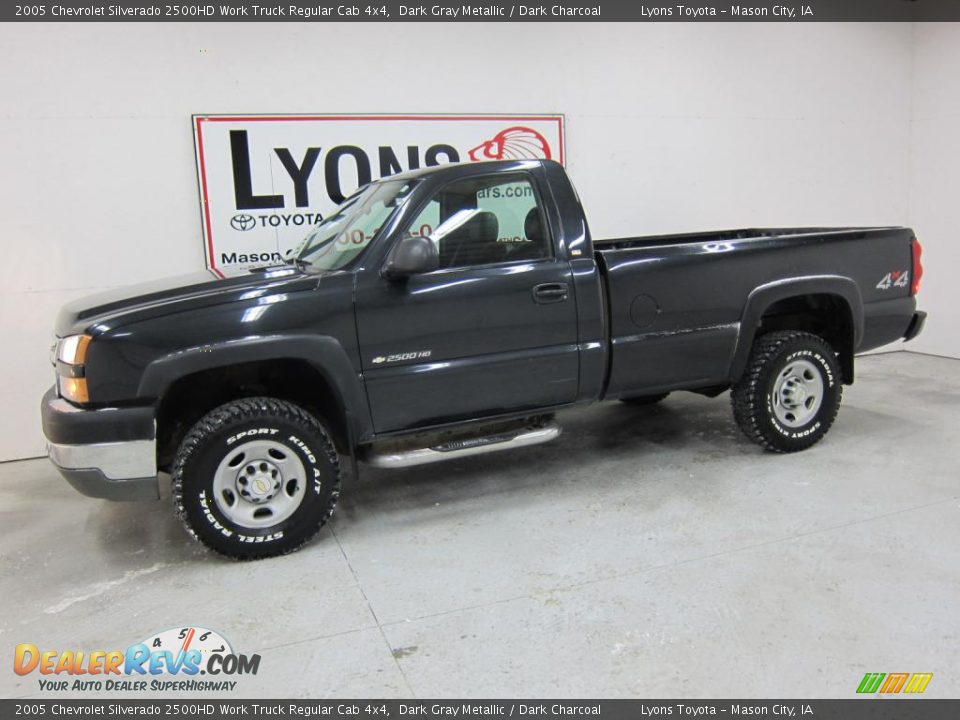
{"left": 173, "top": 397, "right": 340, "bottom": 560}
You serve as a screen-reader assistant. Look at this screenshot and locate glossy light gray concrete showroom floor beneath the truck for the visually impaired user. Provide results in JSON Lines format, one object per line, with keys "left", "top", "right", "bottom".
{"left": 0, "top": 353, "right": 960, "bottom": 698}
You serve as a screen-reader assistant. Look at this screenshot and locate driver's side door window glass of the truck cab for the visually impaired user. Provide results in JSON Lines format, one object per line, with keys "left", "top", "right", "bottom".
{"left": 407, "top": 175, "right": 552, "bottom": 268}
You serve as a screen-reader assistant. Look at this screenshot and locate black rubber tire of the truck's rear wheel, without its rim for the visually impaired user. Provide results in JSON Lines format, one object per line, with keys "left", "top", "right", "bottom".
{"left": 730, "top": 331, "right": 843, "bottom": 453}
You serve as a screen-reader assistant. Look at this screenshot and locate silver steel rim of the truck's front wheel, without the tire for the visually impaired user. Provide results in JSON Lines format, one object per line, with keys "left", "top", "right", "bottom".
{"left": 213, "top": 440, "right": 307, "bottom": 530}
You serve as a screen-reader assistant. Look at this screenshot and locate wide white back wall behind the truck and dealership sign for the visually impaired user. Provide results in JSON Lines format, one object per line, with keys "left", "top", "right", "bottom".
{"left": 0, "top": 23, "right": 924, "bottom": 459}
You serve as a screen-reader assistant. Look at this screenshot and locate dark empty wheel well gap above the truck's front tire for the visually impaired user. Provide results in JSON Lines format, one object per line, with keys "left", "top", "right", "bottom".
{"left": 156, "top": 358, "right": 352, "bottom": 470}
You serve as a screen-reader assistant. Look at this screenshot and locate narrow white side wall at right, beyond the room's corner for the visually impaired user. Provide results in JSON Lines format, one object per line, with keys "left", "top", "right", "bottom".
{"left": 906, "top": 23, "right": 960, "bottom": 357}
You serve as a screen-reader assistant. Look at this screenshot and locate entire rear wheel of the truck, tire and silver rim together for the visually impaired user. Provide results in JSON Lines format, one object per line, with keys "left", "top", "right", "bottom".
{"left": 730, "top": 331, "right": 843, "bottom": 452}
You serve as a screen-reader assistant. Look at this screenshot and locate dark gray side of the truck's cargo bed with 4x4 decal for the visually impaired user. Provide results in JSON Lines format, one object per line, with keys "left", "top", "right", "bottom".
{"left": 594, "top": 227, "right": 913, "bottom": 397}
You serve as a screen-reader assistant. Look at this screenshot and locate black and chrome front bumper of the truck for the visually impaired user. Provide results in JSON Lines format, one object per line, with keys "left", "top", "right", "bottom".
{"left": 41, "top": 388, "right": 160, "bottom": 500}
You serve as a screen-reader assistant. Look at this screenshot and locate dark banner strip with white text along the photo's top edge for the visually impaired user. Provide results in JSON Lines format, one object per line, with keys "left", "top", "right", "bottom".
{"left": 0, "top": 0, "right": 960, "bottom": 22}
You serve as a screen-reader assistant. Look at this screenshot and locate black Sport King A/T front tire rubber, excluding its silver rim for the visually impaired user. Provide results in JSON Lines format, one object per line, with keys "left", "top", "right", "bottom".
{"left": 172, "top": 397, "right": 340, "bottom": 560}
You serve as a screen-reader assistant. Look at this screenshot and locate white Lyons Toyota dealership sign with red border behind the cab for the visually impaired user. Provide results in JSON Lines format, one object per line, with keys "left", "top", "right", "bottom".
{"left": 193, "top": 115, "right": 564, "bottom": 275}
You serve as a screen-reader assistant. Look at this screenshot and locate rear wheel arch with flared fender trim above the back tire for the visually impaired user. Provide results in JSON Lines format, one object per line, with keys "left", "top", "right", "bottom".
{"left": 731, "top": 277, "right": 863, "bottom": 385}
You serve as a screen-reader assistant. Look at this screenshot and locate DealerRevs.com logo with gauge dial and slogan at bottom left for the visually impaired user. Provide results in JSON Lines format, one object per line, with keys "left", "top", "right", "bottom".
{"left": 13, "top": 627, "right": 260, "bottom": 692}
